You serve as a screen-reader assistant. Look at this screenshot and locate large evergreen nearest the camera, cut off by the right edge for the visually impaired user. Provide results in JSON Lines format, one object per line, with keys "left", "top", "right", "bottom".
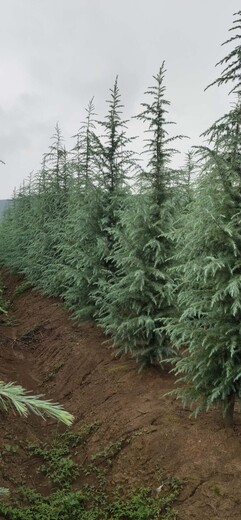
{"left": 166, "top": 12, "right": 241, "bottom": 424}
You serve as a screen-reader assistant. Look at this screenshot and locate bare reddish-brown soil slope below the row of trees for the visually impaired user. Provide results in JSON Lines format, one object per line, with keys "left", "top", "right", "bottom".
{"left": 0, "top": 272, "right": 241, "bottom": 520}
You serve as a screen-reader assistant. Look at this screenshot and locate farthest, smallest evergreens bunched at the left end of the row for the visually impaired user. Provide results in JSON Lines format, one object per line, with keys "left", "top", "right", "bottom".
{"left": 0, "top": 125, "right": 72, "bottom": 295}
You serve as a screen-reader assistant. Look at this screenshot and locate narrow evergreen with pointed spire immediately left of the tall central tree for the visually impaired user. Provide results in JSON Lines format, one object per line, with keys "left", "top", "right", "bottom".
{"left": 92, "top": 77, "right": 137, "bottom": 319}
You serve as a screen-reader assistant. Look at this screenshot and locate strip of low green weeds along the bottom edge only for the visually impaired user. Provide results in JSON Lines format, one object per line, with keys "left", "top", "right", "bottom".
{"left": 0, "top": 479, "right": 180, "bottom": 520}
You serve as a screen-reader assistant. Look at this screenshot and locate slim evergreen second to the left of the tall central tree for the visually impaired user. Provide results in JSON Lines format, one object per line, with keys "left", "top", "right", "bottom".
{"left": 58, "top": 99, "right": 101, "bottom": 319}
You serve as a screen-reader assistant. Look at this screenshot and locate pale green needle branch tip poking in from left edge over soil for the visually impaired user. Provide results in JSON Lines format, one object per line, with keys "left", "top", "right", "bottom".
{"left": 0, "top": 381, "right": 74, "bottom": 426}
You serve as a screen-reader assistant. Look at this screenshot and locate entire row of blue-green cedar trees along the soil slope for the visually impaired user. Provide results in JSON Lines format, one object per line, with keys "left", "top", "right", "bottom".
{"left": 0, "top": 11, "right": 241, "bottom": 423}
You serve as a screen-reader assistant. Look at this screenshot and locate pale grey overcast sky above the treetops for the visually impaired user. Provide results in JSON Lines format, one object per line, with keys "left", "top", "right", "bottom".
{"left": 0, "top": 0, "right": 240, "bottom": 199}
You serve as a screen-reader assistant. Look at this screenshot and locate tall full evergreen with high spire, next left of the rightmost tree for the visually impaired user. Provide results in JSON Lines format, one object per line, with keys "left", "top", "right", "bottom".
{"left": 100, "top": 63, "right": 185, "bottom": 367}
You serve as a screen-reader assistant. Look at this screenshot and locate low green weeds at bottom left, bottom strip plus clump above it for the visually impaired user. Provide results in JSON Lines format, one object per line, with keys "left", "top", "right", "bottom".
{"left": 0, "top": 423, "right": 181, "bottom": 520}
